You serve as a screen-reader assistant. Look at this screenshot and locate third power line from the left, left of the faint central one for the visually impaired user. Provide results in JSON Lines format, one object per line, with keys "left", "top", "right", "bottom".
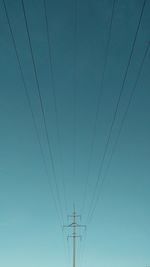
{"left": 43, "top": 0, "right": 67, "bottom": 216}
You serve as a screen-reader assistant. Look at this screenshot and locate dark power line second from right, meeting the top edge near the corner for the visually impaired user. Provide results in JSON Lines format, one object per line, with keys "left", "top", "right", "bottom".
{"left": 87, "top": 0, "right": 147, "bottom": 222}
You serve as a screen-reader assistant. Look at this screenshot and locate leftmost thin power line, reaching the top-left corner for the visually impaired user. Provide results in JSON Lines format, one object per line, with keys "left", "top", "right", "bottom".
{"left": 3, "top": 0, "right": 61, "bottom": 227}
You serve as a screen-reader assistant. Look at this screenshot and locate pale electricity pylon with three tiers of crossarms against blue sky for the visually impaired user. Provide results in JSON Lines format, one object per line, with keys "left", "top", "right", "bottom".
{"left": 63, "top": 207, "right": 86, "bottom": 267}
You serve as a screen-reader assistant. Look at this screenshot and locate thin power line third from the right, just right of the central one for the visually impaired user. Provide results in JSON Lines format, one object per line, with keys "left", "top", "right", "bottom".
{"left": 82, "top": 0, "right": 116, "bottom": 214}
